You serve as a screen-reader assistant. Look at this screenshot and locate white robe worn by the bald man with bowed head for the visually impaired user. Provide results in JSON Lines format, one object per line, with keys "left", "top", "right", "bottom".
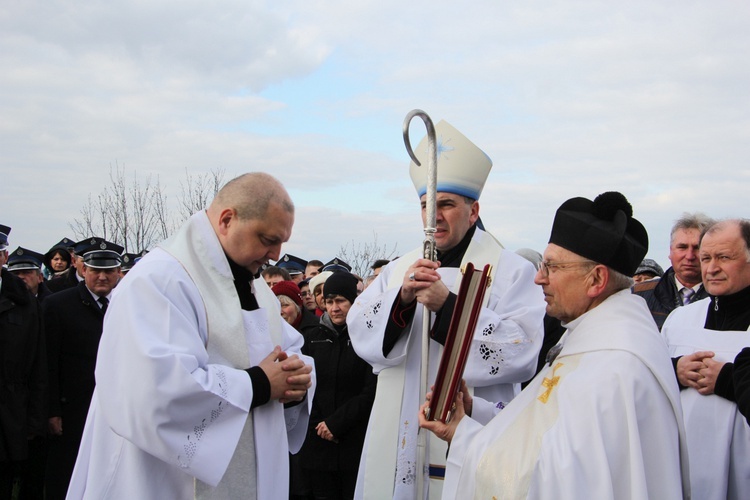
{"left": 68, "top": 212, "right": 314, "bottom": 500}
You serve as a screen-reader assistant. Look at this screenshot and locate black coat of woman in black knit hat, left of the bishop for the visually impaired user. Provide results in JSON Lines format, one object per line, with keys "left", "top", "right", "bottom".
{"left": 301, "top": 314, "right": 377, "bottom": 471}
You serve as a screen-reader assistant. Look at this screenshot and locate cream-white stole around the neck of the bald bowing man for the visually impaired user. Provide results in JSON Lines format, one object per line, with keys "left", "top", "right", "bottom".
{"left": 160, "top": 211, "right": 283, "bottom": 499}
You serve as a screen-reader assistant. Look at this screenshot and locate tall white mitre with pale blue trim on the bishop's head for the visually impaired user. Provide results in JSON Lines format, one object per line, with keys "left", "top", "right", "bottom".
{"left": 409, "top": 120, "right": 492, "bottom": 200}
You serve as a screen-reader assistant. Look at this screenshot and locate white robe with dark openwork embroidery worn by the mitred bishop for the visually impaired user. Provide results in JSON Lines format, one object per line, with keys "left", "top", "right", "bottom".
{"left": 347, "top": 228, "right": 545, "bottom": 500}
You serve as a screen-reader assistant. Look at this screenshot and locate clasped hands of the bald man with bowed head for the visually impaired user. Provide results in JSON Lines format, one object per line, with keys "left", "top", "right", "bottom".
{"left": 258, "top": 346, "right": 312, "bottom": 403}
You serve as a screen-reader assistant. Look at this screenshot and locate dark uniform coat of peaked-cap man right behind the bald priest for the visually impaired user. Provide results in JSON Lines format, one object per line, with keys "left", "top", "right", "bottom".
{"left": 42, "top": 282, "right": 104, "bottom": 498}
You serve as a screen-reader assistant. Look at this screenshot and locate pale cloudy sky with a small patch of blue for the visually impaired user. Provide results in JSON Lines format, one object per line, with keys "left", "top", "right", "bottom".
{"left": 0, "top": 0, "right": 750, "bottom": 274}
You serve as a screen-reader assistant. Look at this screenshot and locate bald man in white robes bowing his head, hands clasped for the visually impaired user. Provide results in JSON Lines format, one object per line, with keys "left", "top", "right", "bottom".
{"left": 68, "top": 173, "right": 314, "bottom": 500}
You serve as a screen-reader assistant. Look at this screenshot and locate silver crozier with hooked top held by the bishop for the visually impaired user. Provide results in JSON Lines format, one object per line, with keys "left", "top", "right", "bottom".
{"left": 404, "top": 109, "right": 437, "bottom": 500}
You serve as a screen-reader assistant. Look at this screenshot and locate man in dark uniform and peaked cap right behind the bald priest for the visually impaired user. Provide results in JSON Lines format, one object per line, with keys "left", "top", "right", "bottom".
{"left": 43, "top": 238, "right": 122, "bottom": 500}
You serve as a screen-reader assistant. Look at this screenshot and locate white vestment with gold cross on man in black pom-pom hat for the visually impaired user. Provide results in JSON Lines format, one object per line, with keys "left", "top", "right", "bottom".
{"left": 443, "top": 290, "right": 689, "bottom": 500}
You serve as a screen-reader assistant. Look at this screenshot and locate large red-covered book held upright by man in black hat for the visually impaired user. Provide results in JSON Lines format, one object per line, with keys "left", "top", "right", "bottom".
{"left": 427, "top": 262, "right": 492, "bottom": 422}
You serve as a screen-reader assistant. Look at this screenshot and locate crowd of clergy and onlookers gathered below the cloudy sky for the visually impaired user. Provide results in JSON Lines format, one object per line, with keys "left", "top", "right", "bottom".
{"left": 0, "top": 121, "right": 750, "bottom": 500}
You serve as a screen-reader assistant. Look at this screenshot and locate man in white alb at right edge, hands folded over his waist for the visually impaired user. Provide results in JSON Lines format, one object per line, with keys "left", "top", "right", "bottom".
{"left": 662, "top": 220, "right": 750, "bottom": 500}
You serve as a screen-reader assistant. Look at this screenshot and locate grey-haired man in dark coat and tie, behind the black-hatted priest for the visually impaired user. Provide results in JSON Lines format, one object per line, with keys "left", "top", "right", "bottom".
{"left": 632, "top": 213, "right": 713, "bottom": 331}
